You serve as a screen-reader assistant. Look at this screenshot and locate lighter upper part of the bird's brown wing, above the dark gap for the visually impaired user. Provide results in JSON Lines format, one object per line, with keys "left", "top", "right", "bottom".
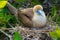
{"left": 18, "top": 8, "right": 34, "bottom": 20}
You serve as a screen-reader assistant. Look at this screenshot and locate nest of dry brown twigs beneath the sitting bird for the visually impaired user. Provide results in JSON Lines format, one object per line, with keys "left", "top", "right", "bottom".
{"left": 16, "top": 25, "right": 55, "bottom": 40}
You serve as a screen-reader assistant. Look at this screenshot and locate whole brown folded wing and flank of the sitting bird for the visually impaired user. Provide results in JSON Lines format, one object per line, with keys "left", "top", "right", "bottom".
{"left": 18, "top": 8, "right": 34, "bottom": 26}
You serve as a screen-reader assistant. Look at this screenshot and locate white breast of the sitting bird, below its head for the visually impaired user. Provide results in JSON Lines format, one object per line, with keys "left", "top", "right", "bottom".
{"left": 32, "top": 13, "right": 46, "bottom": 27}
